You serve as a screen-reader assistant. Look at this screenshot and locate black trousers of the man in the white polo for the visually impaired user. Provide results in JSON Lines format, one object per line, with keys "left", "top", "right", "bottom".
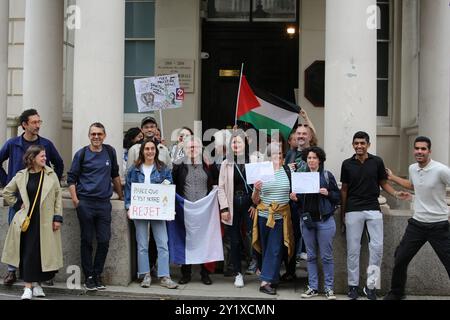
{"left": 391, "top": 218, "right": 450, "bottom": 295}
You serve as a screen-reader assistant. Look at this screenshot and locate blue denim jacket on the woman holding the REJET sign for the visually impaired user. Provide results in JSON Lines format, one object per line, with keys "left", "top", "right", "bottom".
{"left": 125, "top": 165, "right": 173, "bottom": 210}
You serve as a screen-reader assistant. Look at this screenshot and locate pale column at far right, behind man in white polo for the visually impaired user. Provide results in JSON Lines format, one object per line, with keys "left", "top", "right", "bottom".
{"left": 419, "top": 0, "right": 450, "bottom": 165}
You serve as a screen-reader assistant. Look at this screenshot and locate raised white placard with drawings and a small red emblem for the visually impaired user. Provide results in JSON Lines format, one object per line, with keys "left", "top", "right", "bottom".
{"left": 134, "top": 74, "right": 184, "bottom": 112}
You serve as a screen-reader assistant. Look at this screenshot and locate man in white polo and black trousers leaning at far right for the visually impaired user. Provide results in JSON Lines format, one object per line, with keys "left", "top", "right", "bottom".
{"left": 384, "top": 137, "right": 450, "bottom": 300}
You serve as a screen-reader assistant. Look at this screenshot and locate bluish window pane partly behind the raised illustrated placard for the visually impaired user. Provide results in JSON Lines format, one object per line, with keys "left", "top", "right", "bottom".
{"left": 124, "top": 0, "right": 155, "bottom": 113}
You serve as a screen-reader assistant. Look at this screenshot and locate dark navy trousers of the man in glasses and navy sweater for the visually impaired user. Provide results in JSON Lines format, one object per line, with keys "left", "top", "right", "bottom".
{"left": 77, "top": 199, "right": 112, "bottom": 278}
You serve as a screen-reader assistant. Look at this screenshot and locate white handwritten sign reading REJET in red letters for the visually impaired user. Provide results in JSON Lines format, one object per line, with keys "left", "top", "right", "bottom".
{"left": 130, "top": 183, "right": 175, "bottom": 220}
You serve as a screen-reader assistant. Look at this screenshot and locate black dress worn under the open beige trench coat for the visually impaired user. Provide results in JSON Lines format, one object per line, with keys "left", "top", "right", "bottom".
{"left": 19, "top": 172, "right": 56, "bottom": 282}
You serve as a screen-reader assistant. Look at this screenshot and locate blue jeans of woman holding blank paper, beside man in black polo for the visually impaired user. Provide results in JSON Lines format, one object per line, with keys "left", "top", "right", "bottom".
{"left": 300, "top": 217, "right": 336, "bottom": 290}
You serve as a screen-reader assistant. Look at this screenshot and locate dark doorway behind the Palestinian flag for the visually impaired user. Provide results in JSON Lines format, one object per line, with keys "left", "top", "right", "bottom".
{"left": 201, "top": 22, "right": 299, "bottom": 130}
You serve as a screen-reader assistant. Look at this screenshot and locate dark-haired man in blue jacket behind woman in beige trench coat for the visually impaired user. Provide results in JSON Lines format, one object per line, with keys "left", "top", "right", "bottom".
{"left": 0, "top": 109, "right": 64, "bottom": 286}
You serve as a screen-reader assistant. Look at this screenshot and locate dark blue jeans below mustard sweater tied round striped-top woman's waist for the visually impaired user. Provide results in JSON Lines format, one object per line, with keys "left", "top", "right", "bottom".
{"left": 258, "top": 216, "right": 283, "bottom": 283}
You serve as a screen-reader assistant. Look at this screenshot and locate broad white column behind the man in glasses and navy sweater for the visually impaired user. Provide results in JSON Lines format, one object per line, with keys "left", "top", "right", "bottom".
{"left": 72, "top": 0, "right": 125, "bottom": 159}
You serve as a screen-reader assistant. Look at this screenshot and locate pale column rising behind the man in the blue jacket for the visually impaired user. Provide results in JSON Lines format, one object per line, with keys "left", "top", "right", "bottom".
{"left": 23, "top": 0, "right": 64, "bottom": 148}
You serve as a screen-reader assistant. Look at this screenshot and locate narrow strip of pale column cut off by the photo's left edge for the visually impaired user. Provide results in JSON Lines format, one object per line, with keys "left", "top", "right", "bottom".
{"left": 0, "top": 0, "right": 9, "bottom": 145}
